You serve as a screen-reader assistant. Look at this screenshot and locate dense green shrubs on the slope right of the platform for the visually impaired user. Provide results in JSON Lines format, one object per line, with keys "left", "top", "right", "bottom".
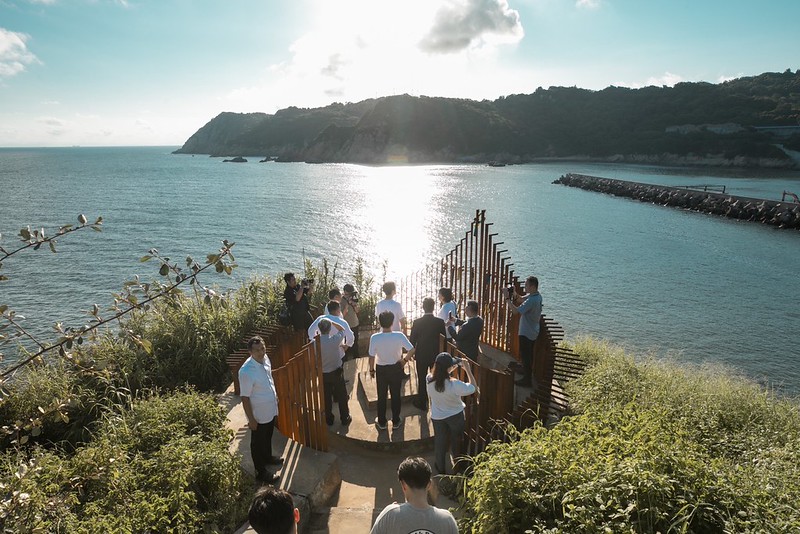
{"left": 462, "top": 340, "right": 800, "bottom": 533}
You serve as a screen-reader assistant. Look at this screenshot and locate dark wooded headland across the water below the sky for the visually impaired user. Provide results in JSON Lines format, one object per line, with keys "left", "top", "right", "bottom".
{"left": 176, "top": 70, "right": 800, "bottom": 167}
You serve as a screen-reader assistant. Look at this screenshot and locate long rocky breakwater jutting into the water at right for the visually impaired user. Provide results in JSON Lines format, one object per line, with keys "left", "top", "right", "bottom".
{"left": 553, "top": 173, "right": 800, "bottom": 229}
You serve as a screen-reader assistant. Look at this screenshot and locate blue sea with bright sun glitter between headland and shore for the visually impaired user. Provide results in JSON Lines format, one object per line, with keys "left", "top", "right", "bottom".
{"left": 0, "top": 147, "right": 800, "bottom": 395}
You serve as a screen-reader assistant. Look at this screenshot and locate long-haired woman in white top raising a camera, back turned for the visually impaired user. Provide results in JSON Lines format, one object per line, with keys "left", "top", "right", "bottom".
{"left": 427, "top": 352, "right": 480, "bottom": 475}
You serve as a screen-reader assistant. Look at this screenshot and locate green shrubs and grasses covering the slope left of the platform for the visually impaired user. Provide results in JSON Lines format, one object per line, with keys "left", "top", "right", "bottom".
{"left": 0, "top": 218, "right": 374, "bottom": 533}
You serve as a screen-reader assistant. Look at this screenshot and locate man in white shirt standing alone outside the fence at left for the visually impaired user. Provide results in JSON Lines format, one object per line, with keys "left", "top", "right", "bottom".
{"left": 239, "top": 336, "right": 283, "bottom": 484}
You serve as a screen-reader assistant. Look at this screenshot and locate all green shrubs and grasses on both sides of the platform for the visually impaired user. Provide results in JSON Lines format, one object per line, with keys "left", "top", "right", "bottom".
{"left": 0, "top": 219, "right": 800, "bottom": 533}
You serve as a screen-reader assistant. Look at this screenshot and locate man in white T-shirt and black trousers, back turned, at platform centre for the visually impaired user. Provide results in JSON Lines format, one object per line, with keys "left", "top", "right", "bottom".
{"left": 369, "top": 311, "right": 415, "bottom": 430}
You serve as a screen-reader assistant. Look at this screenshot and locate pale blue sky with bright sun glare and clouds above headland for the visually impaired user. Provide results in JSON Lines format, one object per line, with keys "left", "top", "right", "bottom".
{"left": 0, "top": 0, "right": 800, "bottom": 146}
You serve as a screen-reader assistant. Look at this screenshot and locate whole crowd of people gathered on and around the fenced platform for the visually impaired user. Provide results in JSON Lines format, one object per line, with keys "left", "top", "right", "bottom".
{"left": 239, "top": 273, "right": 542, "bottom": 533}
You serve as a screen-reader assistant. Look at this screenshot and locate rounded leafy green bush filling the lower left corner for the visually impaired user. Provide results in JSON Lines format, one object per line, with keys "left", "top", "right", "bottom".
{"left": 0, "top": 392, "right": 252, "bottom": 533}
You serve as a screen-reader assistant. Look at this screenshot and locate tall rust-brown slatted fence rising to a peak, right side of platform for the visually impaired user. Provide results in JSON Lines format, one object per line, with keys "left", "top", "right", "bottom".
{"left": 398, "top": 210, "right": 584, "bottom": 455}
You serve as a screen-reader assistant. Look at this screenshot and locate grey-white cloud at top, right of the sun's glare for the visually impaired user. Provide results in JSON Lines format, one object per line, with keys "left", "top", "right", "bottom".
{"left": 419, "top": 0, "right": 523, "bottom": 54}
